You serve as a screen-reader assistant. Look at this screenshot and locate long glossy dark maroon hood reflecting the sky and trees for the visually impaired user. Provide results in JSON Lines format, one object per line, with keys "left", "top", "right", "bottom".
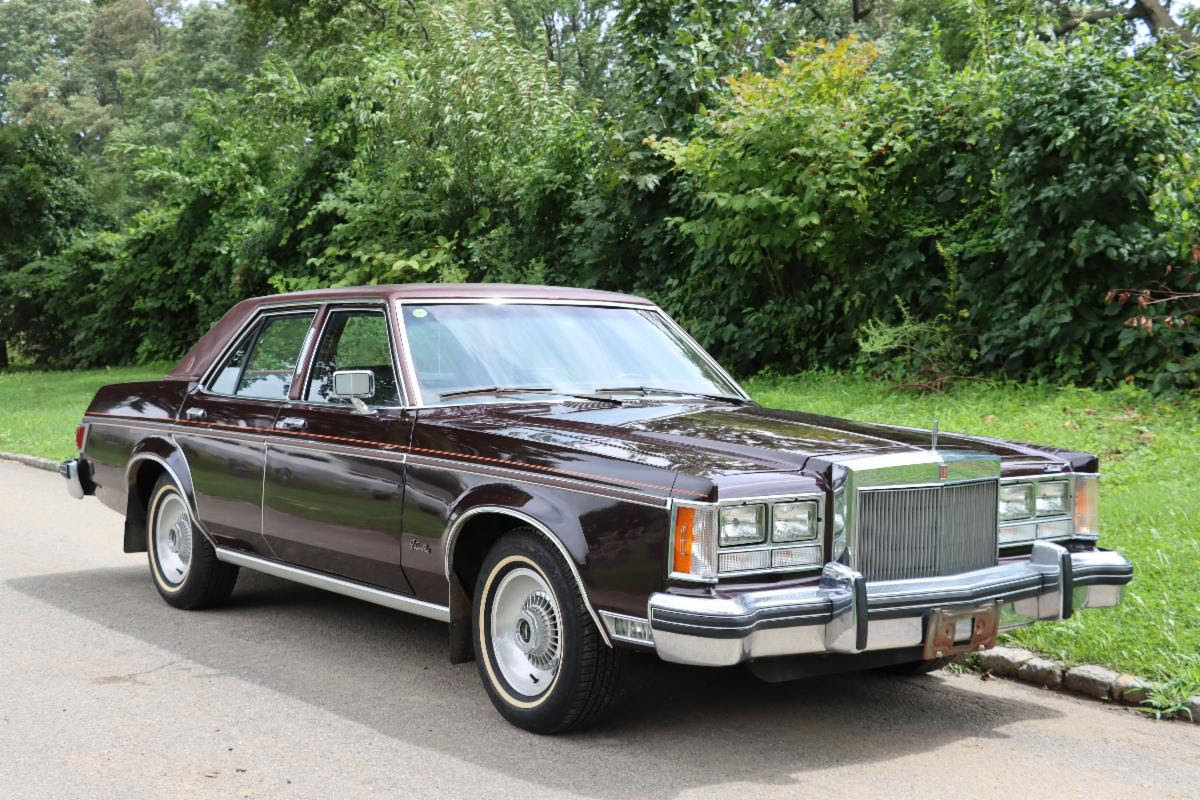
{"left": 429, "top": 402, "right": 1051, "bottom": 477}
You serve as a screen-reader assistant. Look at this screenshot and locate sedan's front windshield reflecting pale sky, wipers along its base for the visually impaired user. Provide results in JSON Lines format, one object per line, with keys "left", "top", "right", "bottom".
{"left": 401, "top": 303, "right": 740, "bottom": 405}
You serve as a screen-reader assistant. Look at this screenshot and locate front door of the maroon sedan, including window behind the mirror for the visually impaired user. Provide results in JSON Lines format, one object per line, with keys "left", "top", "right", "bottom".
{"left": 263, "top": 305, "right": 413, "bottom": 593}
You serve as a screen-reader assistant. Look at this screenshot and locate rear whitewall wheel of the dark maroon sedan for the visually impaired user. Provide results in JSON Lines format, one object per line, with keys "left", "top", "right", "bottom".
{"left": 146, "top": 475, "right": 238, "bottom": 608}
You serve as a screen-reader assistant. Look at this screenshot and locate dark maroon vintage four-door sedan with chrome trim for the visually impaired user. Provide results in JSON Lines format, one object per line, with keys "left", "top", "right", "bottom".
{"left": 61, "top": 284, "right": 1133, "bottom": 733}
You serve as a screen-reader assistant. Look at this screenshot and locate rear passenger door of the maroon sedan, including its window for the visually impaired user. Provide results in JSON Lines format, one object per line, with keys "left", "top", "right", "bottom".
{"left": 175, "top": 308, "right": 317, "bottom": 557}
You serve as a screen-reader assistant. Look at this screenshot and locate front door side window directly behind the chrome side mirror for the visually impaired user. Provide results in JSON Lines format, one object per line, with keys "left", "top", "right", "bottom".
{"left": 305, "top": 311, "right": 400, "bottom": 405}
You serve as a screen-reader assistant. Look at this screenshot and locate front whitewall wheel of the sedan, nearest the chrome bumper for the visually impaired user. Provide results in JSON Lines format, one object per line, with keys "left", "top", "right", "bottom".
{"left": 470, "top": 528, "right": 624, "bottom": 734}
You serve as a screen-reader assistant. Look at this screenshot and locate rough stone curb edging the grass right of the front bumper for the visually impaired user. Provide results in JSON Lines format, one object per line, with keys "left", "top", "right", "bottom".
{"left": 976, "top": 648, "right": 1200, "bottom": 724}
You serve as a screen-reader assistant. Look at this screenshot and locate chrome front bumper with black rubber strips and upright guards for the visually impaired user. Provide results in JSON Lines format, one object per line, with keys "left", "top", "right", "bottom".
{"left": 648, "top": 542, "right": 1133, "bottom": 667}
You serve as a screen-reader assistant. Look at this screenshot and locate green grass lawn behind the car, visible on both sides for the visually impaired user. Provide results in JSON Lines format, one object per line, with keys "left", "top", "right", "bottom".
{"left": 0, "top": 365, "right": 1200, "bottom": 692}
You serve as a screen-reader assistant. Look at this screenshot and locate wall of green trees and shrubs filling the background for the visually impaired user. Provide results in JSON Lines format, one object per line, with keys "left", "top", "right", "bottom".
{"left": 0, "top": 0, "right": 1200, "bottom": 387}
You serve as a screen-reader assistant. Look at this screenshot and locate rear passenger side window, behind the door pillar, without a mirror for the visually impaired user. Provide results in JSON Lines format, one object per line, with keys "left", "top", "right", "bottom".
{"left": 209, "top": 312, "right": 313, "bottom": 401}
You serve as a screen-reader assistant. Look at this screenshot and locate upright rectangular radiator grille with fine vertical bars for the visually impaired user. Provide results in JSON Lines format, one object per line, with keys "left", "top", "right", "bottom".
{"left": 854, "top": 481, "right": 998, "bottom": 581}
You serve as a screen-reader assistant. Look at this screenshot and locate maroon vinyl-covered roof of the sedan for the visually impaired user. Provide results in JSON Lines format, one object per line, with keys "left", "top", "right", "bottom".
{"left": 166, "top": 283, "right": 654, "bottom": 380}
